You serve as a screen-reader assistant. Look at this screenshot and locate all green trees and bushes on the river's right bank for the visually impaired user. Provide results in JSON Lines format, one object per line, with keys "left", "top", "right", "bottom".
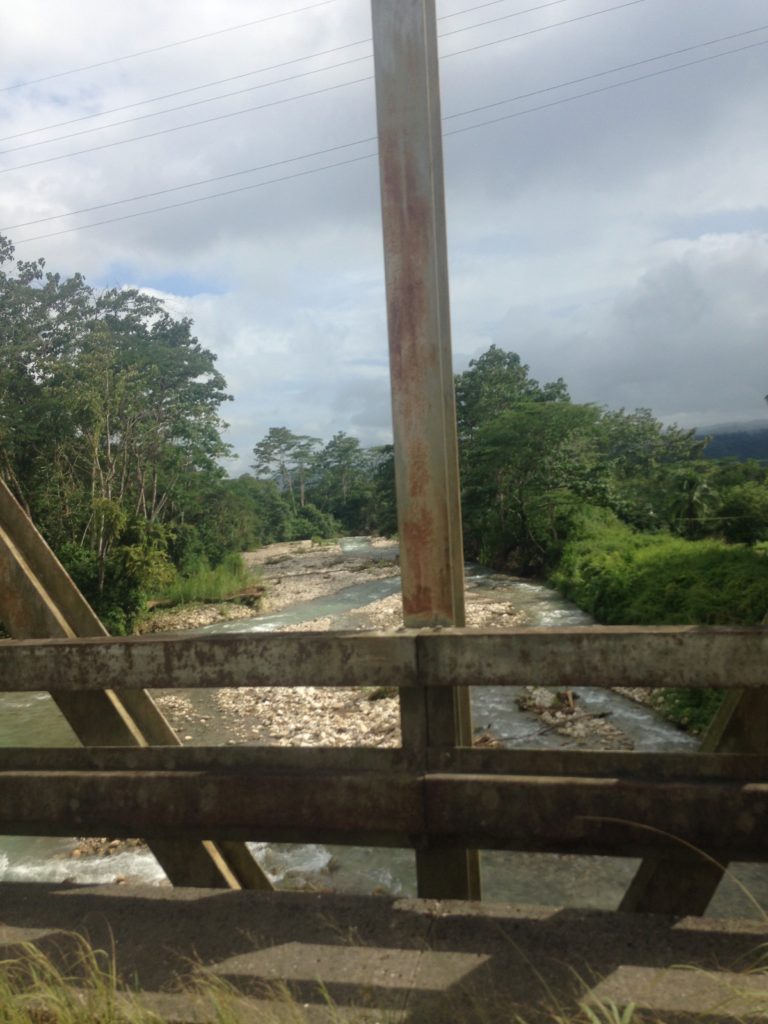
{"left": 457, "top": 347, "right": 768, "bottom": 731}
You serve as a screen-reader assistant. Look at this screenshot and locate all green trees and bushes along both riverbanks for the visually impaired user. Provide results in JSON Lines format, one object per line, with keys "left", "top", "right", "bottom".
{"left": 0, "top": 239, "right": 768, "bottom": 659}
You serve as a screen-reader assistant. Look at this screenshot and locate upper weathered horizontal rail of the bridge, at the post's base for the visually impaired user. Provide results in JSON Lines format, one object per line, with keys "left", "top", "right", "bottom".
{"left": 0, "top": 627, "right": 768, "bottom": 692}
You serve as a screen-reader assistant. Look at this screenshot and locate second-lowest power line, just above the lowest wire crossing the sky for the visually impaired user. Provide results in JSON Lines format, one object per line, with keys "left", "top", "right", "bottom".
{"left": 6, "top": 24, "right": 768, "bottom": 231}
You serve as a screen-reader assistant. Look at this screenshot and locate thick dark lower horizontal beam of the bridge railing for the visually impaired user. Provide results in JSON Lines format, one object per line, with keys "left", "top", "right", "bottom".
{"left": 0, "top": 771, "right": 768, "bottom": 860}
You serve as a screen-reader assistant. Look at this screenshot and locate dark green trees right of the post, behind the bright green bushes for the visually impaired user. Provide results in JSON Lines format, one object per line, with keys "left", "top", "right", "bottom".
{"left": 457, "top": 346, "right": 737, "bottom": 573}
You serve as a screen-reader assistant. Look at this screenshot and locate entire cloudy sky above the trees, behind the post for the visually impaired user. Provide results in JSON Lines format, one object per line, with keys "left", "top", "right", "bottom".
{"left": 0, "top": 0, "right": 768, "bottom": 474}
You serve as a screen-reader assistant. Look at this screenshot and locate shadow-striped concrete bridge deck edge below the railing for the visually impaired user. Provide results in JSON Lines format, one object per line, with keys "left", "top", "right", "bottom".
{"left": 0, "top": 884, "right": 768, "bottom": 1024}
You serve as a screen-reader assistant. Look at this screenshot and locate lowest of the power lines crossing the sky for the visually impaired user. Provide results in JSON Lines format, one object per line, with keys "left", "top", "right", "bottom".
{"left": 10, "top": 40, "right": 768, "bottom": 245}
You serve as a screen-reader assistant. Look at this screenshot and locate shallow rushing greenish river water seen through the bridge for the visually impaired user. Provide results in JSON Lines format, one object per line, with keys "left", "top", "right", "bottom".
{"left": 0, "top": 540, "right": 768, "bottom": 916}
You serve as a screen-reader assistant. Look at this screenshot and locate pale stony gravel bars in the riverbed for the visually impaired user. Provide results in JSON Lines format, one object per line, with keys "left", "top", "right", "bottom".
{"left": 138, "top": 540, "right": 632, "bottom": 750}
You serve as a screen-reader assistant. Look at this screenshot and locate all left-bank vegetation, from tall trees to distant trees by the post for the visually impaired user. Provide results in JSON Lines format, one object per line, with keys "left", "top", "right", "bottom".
{"left": 0, "top": 237, "right": 391, "bottom": 633}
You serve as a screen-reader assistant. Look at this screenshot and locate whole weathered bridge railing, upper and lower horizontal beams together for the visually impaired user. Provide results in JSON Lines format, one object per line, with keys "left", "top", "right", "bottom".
{"left": 0, "top": 627, "right": 768, "bottom": 861}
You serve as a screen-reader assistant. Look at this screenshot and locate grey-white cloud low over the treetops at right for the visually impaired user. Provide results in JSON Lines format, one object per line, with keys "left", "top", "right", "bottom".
{"left": 493, "top": 233, "right": 768, "bottom": 426}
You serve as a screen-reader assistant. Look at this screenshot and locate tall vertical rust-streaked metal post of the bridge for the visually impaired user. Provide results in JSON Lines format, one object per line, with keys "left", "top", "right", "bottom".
{"left": 372, "top": 0, "right": 480, "bottom": 898}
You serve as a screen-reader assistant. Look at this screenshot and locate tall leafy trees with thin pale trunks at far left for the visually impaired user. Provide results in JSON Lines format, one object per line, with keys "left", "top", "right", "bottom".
{"left": 0, "top": 239, "right": 234, "bottom": 628}
